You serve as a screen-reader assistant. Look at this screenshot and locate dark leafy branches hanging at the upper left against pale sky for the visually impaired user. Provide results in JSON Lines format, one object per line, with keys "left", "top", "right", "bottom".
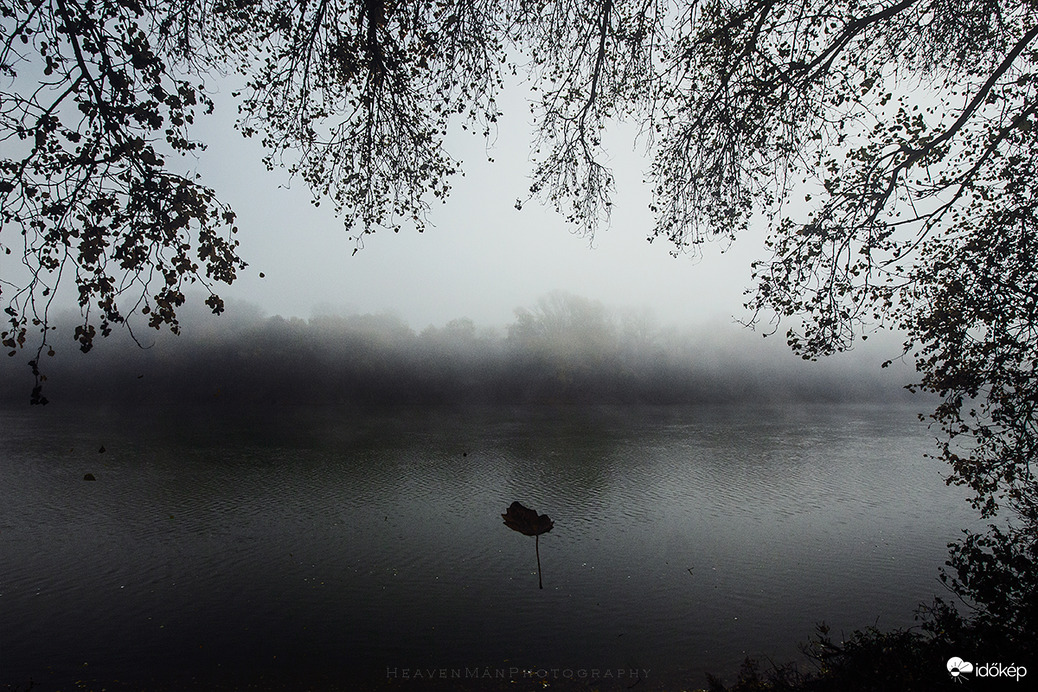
{"left": 0, "top": 0, "right": 251, "bottom": 403}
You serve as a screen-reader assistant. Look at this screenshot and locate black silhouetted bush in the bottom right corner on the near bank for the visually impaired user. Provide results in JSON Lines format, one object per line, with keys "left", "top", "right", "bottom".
{"left": 708, "top": 516, "right": 1038, "bottom": 692}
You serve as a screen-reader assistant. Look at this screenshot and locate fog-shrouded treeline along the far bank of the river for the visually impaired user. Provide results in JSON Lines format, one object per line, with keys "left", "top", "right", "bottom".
{"left": 0, "top": 292, "right": 925, "bottom": 406}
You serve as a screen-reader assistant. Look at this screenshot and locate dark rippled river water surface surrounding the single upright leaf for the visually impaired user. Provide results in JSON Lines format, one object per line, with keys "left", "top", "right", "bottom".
{"left": 0, "top": 407, "right": 971, "bottom": 689}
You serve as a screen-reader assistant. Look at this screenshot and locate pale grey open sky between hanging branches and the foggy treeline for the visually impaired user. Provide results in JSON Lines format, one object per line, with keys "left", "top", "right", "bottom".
{"left": 186, "top": 76, "right": 762, "bottom": 329}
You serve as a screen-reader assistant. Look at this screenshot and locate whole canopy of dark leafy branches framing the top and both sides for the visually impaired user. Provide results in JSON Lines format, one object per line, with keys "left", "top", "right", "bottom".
{"left": 0, "top": 0, "right": 1038, "bottom": 513}
